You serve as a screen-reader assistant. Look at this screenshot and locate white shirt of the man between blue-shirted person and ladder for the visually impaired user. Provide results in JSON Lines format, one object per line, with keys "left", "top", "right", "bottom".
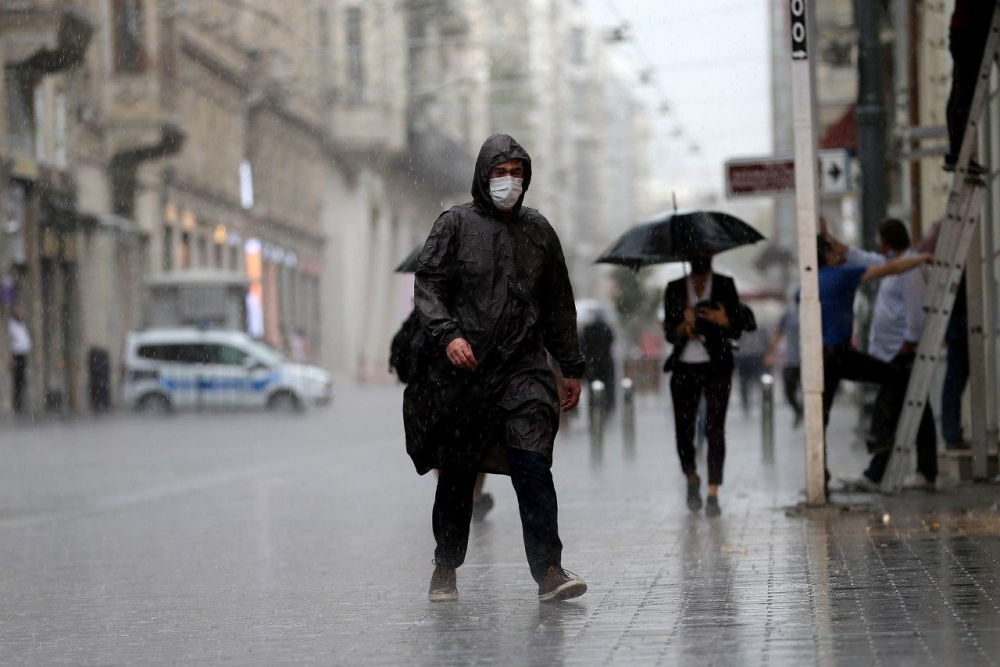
{"left": 847, "top": 248, "right": 925, "bottom": 362}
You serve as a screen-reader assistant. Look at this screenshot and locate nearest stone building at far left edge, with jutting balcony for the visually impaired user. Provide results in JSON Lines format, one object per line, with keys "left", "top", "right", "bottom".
{"left": 0, "top": 2, "right": 95, "bottom": 416}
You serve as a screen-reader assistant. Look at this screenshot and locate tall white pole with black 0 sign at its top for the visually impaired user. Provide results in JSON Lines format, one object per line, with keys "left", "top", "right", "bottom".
{"left": 789, "top": 0, "right": 826, "bottom": 505}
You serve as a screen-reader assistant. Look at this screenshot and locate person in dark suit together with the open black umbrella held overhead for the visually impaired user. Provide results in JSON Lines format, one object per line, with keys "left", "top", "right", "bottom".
{"left": 598, "top": 211, "right": 763, "bottom": 517}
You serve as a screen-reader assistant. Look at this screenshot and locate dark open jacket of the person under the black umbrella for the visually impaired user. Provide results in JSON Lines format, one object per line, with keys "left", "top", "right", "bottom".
{"left": 663, "top": 273, "right": 757, "bottom": 373}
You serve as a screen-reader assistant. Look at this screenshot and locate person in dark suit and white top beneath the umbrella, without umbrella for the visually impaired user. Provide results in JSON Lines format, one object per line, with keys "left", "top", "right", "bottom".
{"left": 663, "top": 254, "right": 757, "bottom": 517}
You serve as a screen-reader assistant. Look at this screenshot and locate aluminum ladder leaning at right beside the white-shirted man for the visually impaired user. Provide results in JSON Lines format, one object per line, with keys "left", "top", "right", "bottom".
{"left": 881, "top": 10, "right": 1000, "bottom": 493}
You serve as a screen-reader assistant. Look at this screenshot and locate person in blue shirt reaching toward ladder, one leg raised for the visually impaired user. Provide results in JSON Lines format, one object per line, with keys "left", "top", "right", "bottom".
{"left": 816, "top": 234, "right": 933, "bottom": 488}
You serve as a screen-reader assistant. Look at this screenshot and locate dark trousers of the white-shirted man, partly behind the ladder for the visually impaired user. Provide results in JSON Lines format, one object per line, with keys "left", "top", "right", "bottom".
{"left": 865, "top": 352, "right": 937, "bottom": 482}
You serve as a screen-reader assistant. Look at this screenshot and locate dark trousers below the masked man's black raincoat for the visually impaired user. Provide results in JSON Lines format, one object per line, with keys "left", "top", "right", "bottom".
{"left": 433, "top": 447, "right": 562, "bottom": 582}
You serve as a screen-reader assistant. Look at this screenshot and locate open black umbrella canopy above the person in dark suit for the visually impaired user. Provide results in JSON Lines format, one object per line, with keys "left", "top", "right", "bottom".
{"left": 596, "top": 211, "right": 764, "bottom": 270}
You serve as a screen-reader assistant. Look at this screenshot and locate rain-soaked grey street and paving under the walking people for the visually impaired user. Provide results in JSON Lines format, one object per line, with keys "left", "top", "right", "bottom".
{"left": 0, "top": 387, "right": 1000, "bottom": 665}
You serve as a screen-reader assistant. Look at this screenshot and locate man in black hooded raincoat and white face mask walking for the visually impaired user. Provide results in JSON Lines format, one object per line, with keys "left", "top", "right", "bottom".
{"left": 403, "top": 134, "right": 587, "bottom": 601}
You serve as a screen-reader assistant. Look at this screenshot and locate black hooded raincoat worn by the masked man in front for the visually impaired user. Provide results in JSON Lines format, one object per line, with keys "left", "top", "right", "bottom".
{"left": 403, "top": 134, "right": 584, "bottom": 474}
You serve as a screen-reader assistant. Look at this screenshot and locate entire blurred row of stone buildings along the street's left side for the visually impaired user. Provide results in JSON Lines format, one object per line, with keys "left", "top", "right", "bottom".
{"left": 0, "top": 0, "right": 648, "bottom": 415}
